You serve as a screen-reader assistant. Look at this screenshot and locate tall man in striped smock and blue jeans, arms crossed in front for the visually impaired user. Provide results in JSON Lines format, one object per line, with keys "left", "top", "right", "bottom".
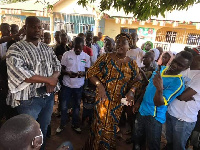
{"left": 6, "top": 16, "right": 61, "bottom": 149}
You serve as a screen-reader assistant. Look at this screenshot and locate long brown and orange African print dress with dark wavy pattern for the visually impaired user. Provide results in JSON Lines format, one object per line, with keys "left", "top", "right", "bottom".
{"left": 84, "top": 54, "right": 140, "bottom": 150}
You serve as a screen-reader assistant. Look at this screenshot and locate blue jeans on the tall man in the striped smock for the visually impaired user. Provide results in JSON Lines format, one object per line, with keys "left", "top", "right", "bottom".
{"left": 17, "top": 94, "right": 54, "bottom": 150}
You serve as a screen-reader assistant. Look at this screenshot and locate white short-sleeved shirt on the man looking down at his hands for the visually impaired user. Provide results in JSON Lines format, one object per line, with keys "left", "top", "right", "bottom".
{"left": 61, "top": 49, "right": 90, "bottom": 88}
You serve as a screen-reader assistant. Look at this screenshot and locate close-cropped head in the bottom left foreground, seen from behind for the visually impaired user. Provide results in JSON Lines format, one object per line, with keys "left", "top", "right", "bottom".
{"left": 0, "top": 114, "right": 40, "bottom": 150}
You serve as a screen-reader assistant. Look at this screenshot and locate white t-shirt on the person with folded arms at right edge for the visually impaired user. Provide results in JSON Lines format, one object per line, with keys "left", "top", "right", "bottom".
{"left": 168, "top": 69, "right": 200, "bottom": 122}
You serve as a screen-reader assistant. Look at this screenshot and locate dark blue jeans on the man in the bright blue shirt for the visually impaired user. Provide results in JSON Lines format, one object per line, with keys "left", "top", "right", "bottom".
{"left": 133, "top": 113, "right": 162, "bottom": 150}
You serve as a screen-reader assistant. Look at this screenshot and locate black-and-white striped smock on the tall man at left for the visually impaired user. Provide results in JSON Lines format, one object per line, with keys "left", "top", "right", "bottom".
{"left": 6, "top": 41, "right": 61, "bottom": 107}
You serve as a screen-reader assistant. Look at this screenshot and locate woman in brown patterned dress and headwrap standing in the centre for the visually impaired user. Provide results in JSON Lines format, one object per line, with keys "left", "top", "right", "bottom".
{"left": 84, "top": 33, "right": 140, "bottom": 150}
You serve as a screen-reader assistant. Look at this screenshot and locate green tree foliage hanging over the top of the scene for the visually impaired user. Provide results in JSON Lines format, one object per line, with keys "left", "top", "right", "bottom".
{"left": 78, "top": 0, "right": 200, "bottom": 20}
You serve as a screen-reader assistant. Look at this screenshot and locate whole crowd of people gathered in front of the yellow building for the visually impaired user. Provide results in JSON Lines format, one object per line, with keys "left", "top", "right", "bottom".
{"left": 0, "top": 16, "right": 200, "bottom": 150}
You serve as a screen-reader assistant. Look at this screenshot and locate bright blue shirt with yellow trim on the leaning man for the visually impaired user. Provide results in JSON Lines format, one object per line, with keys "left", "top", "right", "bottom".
{"left": 139, "top": 66, "right": 185, "bottom": 123}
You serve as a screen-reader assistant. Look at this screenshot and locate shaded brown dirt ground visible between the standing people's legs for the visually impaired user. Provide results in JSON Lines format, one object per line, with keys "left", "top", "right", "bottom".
{"left": 46, "top": 113, "right": 132, "bottom": 150}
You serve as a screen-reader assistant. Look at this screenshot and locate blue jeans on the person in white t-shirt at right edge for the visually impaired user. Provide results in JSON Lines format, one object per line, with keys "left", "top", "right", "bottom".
{"left": 166, "top": 113, "right": 196, "bottom": 150}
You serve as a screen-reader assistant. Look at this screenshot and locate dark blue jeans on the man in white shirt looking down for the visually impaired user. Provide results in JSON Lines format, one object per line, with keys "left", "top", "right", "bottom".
{"left": 60, "top": 86, "right": 83, "bottom": 127}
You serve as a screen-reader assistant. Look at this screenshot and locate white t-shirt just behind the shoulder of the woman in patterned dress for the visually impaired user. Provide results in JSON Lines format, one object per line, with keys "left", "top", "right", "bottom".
{"left": 126, "top": 48, "right": 145, "bottom": 67}
